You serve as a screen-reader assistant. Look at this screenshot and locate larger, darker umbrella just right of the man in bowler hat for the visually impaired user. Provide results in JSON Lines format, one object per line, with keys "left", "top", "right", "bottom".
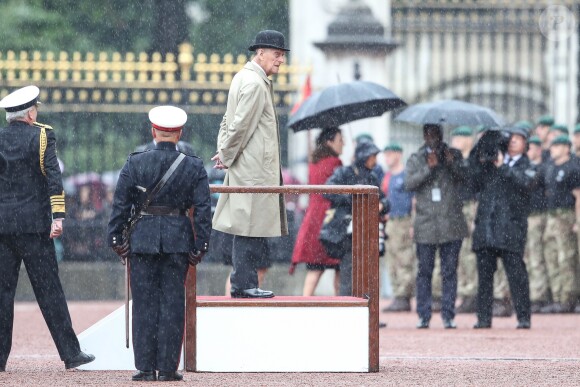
{"left": 288, "top": 81, "right": 407, "bottom": 132}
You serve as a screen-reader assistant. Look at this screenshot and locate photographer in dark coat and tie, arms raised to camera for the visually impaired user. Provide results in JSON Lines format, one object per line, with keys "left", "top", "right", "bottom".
{"left": 470, "top": 128, "right": 535, "bottom": 329}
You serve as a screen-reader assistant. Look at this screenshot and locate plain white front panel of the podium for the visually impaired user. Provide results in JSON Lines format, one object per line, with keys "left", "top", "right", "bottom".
{"left": 196, "top": 307, "right": 369, "bottom": 372}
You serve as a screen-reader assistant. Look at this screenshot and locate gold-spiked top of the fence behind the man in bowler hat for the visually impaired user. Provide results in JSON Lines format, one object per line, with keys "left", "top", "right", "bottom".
{"left": 0, "top": 43, "right": 310, "bottom": 114}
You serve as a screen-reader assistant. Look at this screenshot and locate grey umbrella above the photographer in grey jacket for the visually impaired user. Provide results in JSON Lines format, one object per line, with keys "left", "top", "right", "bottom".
{"left": 395, "top": 99, "right": 504, "bottom": 128}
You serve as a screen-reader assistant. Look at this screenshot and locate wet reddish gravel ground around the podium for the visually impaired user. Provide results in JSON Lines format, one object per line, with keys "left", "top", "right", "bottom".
{"left": 0, "top": 301, "right": 580, "bottom": 387}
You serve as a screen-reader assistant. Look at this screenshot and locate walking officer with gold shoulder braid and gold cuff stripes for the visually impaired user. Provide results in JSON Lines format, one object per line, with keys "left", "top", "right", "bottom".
{"left": 0, "top": 86, "right": 95, "bottom": 371}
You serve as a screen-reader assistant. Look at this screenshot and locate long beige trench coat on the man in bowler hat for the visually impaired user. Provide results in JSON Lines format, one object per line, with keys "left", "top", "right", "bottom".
{"left": 213, "top": 62, "right": 288, "bottom": 237}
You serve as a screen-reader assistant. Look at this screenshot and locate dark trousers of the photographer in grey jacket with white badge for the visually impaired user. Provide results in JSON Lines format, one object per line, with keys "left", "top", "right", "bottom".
{"left": 417, "top": 240, "right": 462, "bottom": 320}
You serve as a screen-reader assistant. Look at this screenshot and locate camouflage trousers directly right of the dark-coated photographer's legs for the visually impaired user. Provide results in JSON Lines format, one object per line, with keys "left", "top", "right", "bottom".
{"left": 524, "top": 213, "right": 550, "bottom": 302}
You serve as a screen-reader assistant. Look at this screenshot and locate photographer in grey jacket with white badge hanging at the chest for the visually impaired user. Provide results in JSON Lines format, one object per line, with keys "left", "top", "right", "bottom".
{"left": 405, "top": 124, "right": 467, "bottom": 329}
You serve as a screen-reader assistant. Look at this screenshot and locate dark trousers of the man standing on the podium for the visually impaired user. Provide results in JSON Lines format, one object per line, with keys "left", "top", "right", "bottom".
{"left": 230, "top": 235, "right": 268, "bottom": 292}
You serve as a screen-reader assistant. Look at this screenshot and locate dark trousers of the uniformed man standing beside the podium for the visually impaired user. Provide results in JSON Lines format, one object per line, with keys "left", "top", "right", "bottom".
{"left": 130, "top": 254, "right": 189, "bottom": 371}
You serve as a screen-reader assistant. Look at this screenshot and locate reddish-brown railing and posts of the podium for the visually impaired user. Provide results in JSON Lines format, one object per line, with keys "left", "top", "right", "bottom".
{"left": 184, "top": 185, "right": 379, "bottom": 372}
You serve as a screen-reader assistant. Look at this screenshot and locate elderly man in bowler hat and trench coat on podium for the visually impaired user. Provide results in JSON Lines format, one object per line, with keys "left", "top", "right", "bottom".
{"left": 212, "top": 30, "right": 289, "bottom": 298}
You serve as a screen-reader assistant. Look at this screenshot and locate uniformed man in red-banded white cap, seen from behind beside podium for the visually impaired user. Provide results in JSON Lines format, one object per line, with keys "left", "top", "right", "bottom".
{"left": 108, "top": 106, "right": 211, "bottom": 381}
